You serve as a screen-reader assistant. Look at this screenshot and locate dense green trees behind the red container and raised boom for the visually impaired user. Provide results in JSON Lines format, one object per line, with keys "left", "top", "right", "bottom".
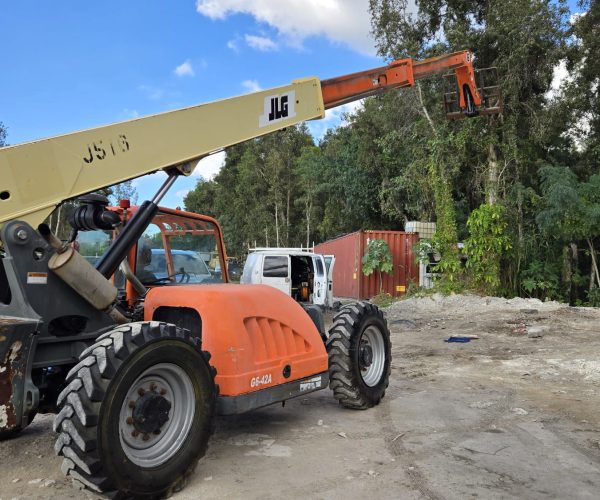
{"left": 179, "top": 0, "right": 600, "bottom": 303}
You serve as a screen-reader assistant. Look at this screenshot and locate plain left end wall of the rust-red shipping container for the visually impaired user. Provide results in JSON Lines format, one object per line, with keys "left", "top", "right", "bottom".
{"left": 315, "top": 231, "right": 362, "bottom": 299}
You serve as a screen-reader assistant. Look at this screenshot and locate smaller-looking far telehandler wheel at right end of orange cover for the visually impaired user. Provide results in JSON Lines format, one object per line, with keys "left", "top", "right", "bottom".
{"left": 327, "top": 302, "right": 392, "bottom": 410}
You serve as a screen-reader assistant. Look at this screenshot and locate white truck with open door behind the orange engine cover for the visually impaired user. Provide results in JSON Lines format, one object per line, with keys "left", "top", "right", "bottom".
{"left": 240, "top": 248, "right": 335, "bottom": 307}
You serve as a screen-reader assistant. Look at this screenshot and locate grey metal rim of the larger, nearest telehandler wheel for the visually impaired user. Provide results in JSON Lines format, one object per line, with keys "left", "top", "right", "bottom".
{"left": 119, "top": 363, "right": 196, "bottom": 468}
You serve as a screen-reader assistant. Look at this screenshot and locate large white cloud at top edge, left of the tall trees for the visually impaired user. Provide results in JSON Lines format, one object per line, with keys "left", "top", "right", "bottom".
{"left": 196, "top": 0, "right": 375, "bottom": 54}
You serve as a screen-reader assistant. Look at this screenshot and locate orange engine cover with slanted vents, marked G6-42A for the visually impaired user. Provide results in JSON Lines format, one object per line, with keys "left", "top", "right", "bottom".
{"left": 144, "top": 284, "right": 328, "bottom": 396}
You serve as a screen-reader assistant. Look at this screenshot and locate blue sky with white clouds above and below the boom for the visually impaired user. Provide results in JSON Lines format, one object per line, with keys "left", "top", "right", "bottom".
{"left": 0, "top": 0, "right": 575, "bottom": 206}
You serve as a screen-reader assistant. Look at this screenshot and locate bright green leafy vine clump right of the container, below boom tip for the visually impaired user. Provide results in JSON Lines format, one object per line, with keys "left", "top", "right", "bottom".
{"left": 464, "top": 205, "right": 512, "bottom": 295}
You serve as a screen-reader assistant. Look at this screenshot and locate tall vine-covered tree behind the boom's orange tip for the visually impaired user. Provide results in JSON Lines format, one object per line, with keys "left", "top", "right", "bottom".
{"left": 370, "top": 0, "right": 569, "bottom": 292}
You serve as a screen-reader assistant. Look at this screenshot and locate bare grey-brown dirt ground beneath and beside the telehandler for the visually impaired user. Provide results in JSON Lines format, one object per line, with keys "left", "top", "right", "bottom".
{"left": 0, "top": 296, "right": 600, "bottom": 500}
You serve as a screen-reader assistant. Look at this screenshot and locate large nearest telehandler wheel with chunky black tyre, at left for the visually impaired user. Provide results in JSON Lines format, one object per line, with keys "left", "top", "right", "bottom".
{"left": 54, "top": 322, "right": 217, "bottom": 497}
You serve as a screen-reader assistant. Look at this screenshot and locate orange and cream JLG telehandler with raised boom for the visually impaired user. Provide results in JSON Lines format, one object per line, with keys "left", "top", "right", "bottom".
{"left": 0, "top": 52, "right": 501, "bottom": 497}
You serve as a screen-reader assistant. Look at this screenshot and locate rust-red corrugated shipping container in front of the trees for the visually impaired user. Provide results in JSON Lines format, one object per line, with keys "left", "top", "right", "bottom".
{"left": 314, "top": 231, "right": 419, "bottom": 300}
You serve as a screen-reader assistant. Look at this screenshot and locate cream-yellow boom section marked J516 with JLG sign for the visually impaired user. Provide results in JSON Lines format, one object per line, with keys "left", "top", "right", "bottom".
{"left": 0, "top": 78, "right": 325, "bottom": 227}
